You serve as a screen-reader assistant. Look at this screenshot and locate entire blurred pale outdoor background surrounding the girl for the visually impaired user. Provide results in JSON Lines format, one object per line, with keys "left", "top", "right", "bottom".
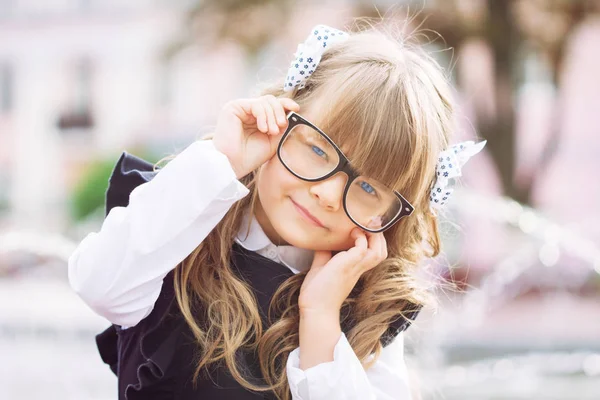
{"left": 0, "top": 0, "right": 600, "bottom": 400}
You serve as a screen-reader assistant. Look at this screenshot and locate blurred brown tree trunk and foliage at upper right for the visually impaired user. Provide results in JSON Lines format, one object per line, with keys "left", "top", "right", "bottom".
{"left": 357, "top": 0, "right": 598, "bottom": 204}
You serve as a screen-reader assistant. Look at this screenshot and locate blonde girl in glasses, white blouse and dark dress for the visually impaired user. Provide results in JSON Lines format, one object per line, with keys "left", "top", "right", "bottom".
{"left": 69, "top": 25, "right": 482, "bottom": 400}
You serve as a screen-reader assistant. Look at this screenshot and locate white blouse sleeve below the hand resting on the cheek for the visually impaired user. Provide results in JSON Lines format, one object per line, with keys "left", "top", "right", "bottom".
{"left": 286, "top": 332, "right": 411, "bottom": 400}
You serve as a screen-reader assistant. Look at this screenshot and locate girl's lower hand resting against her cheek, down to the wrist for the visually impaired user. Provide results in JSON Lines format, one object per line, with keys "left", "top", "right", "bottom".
{"left": 298, "top": 228, "right": 387, "bottom": 315}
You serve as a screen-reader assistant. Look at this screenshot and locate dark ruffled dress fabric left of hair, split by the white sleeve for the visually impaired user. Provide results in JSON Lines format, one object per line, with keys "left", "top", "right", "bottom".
{"left": 96, "top": 151, "right": 185, "bottom": 400}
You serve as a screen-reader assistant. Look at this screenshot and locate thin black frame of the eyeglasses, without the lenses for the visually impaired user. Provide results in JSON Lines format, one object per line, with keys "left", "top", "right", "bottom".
{"left": 277, "top": 111, "right": 415, "bottom": 233}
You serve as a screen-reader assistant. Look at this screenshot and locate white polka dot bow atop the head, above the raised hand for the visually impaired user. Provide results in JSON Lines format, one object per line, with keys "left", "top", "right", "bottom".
{"left": 283, "top": 25, "right": 349, "bottom": 92}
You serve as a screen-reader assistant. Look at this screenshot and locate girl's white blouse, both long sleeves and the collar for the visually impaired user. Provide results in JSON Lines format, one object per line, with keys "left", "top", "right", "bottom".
{"left": 68, "top": 140, "right": 411, "bottom": 400}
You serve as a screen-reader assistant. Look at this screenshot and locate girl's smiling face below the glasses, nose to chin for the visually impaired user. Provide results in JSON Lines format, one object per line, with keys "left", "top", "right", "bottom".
{"left": 254, "top": 156, "right": 356, "bottom": 251}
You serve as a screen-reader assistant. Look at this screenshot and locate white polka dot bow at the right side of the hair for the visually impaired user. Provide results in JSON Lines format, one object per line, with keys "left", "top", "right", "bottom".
{"left": 429, "top": 140, "right": 487, "bottom": 212}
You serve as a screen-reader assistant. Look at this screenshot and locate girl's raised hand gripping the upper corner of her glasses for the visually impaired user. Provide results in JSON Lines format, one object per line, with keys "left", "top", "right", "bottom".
{"left": 213, "top": 95, "right": 300, "bottom": 179}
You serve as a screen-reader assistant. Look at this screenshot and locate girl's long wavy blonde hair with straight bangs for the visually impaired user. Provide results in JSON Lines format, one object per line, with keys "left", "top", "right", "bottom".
{"left": 169, "top": 18, "right": 452, "bottom": 400}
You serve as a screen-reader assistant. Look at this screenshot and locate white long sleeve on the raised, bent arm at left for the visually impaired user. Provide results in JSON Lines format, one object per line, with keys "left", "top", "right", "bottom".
{"left": 68, "top": 140, "right": 249, "bottom": 327}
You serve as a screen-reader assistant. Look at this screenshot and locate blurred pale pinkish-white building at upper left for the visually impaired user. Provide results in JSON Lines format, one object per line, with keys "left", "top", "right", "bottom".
{"left": 0, "top": 0, "right": 243, "bottom": 231}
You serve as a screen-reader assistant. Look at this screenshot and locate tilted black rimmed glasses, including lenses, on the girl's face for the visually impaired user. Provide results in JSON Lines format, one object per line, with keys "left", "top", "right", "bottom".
{"left": 277, "top": 111, "right": 414, "bottom": 233}
